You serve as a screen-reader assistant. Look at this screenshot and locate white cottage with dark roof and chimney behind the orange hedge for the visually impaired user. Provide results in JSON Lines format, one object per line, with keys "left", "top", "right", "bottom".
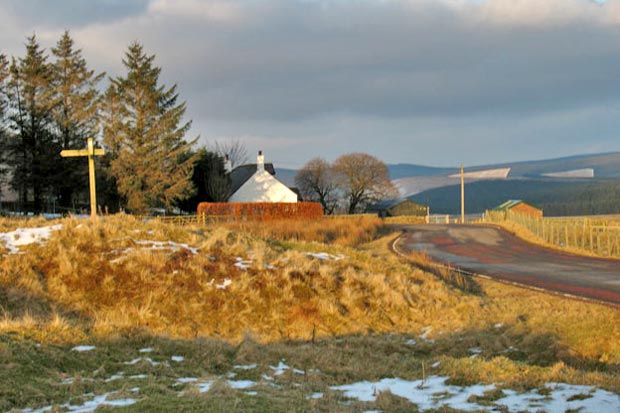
{"left": 228, "top": 151, "right": 298, "bottom": 202}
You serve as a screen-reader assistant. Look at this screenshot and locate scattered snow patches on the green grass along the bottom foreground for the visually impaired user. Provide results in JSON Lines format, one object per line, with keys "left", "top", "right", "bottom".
{"left": 17, "top": 348, "right": 620, "bottom": 413}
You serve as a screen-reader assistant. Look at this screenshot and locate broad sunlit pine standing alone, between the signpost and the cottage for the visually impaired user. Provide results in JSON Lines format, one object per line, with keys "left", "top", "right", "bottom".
{"left": 104, "top": 43, "right": 196, "bottom": 213}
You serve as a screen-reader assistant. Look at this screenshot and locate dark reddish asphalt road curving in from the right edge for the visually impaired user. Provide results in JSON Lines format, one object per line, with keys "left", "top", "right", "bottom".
{"left": 394, "top": 224, "right": 620, "bottom": 305}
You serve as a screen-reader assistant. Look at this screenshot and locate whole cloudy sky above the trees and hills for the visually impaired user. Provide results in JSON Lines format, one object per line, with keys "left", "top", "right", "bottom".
{"left": 0, "top": 0, "right": 620, "bottom": 168}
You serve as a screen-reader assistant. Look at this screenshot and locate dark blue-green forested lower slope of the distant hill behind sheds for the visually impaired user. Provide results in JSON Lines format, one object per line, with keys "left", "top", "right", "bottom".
{"left": 409, "top": 178, "right": 620, "bottom": 216}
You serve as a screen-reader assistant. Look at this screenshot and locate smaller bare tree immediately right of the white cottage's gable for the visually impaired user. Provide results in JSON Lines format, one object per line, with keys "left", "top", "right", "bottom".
{"left": 295, "top": 158, "right": 338, "bottom": 215}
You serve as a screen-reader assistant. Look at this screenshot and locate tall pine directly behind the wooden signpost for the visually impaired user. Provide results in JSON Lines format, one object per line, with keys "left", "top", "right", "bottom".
{"left": 52, "top": 31, "right": 104, "bottom": 211}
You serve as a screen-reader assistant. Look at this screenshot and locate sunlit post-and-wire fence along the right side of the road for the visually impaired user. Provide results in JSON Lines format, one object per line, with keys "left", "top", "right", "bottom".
{"left": 485, "top": 211, "right": 620, "bottom": 257}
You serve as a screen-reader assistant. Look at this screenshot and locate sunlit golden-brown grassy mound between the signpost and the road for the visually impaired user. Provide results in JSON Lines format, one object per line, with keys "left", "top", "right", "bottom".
{"left": 0, "top": 216, "right": 467, "bottom": 341}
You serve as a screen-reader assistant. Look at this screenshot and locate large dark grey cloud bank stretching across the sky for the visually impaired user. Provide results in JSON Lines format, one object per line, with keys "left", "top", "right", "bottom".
{"left": 140, "top": 2, "right": 620, "bottom": 120}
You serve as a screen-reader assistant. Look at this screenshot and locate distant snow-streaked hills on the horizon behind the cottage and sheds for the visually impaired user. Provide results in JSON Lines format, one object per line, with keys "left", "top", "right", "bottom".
{"left": 276, "top": 152, "right": 620, "bottom": 216}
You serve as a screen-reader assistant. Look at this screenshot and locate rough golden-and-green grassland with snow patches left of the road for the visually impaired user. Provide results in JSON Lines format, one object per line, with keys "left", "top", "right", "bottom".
{"left": 0, "top": 216, "right": 620, "bottom": 412}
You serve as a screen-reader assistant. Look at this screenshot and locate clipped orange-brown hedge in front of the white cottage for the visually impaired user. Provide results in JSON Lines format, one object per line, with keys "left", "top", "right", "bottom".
{"left": 198, "top": 202, "right": 323, "bottom": 220}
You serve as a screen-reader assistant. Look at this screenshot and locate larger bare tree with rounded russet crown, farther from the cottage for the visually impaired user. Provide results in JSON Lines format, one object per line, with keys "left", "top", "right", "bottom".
{"left": 334, "top": 153, "right": 396, "bottom": 214}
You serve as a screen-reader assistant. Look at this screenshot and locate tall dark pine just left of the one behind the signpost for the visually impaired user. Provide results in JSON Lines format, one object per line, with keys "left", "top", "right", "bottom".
{"left": 7, "top": 35, "right": 60, "bottom": 212}
